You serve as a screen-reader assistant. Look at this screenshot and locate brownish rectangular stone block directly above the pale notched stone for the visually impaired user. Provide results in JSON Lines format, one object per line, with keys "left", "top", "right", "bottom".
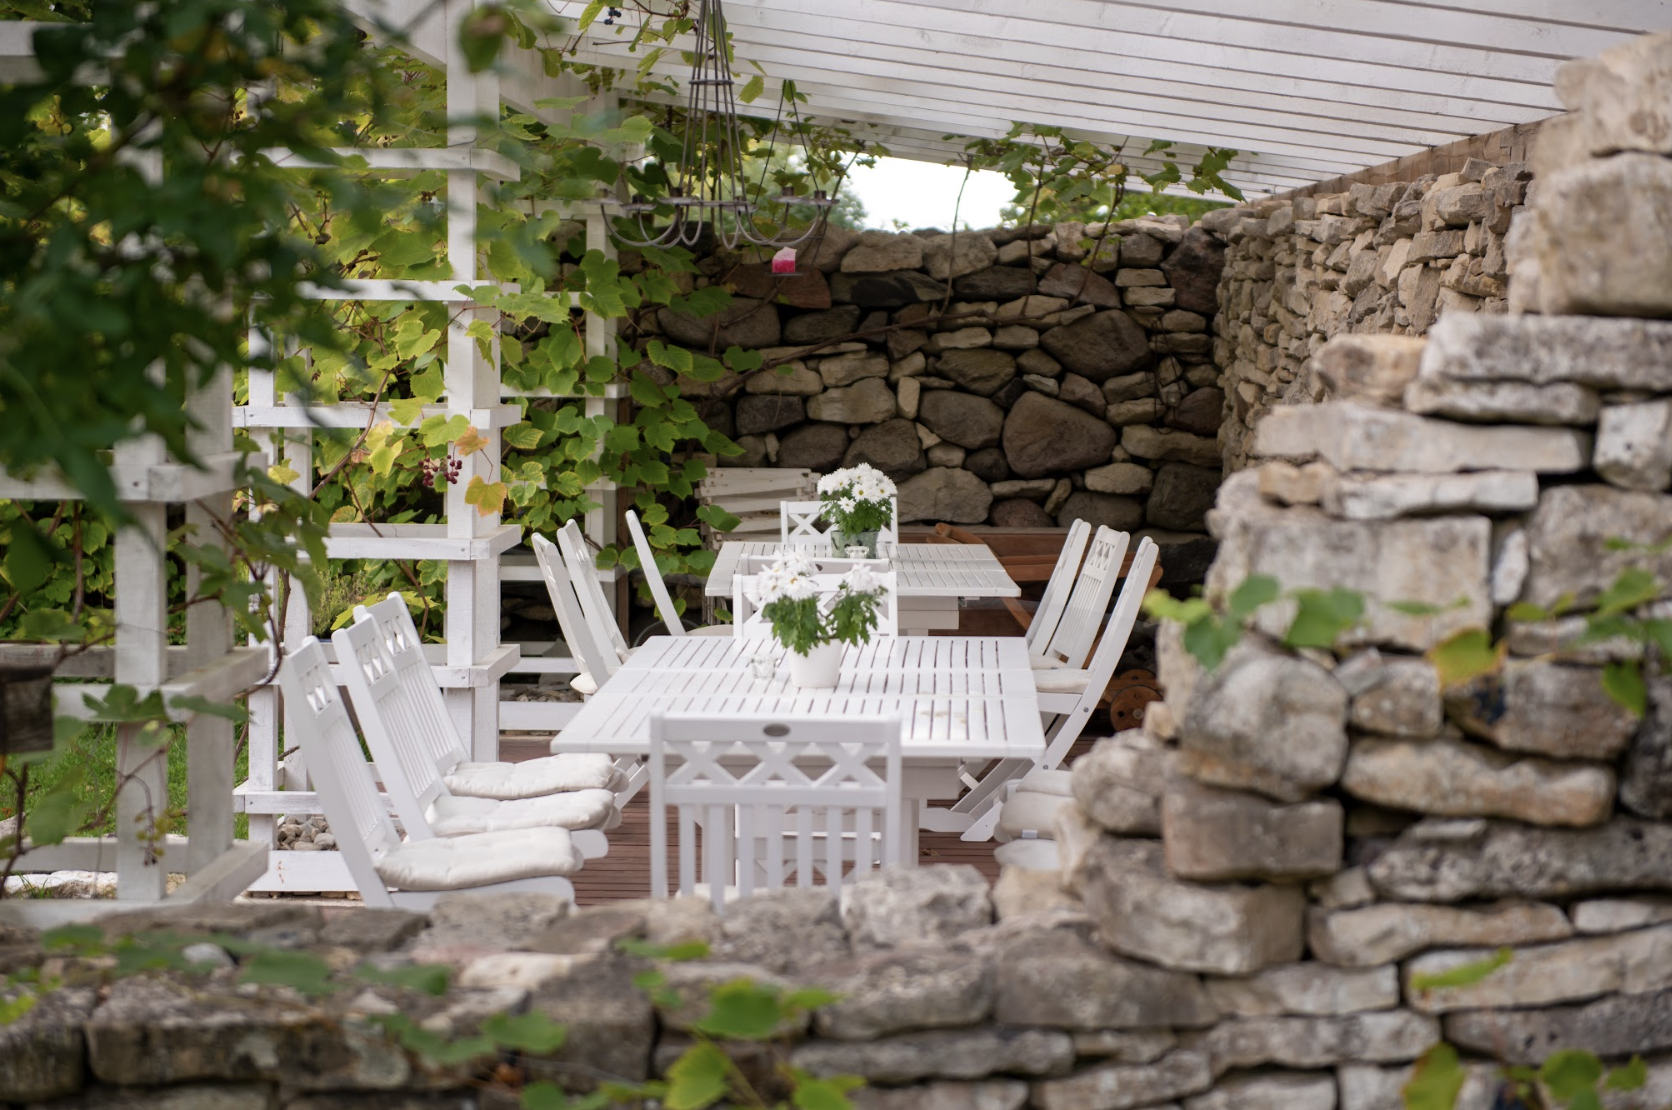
{"left": 1160, "top": 779, "right": 1346, "bottom": 881}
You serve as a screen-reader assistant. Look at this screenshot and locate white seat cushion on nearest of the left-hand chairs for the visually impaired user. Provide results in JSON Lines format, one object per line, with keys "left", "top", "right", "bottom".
{"left": 376, "top": 827, "right": 582, "bottom": 891}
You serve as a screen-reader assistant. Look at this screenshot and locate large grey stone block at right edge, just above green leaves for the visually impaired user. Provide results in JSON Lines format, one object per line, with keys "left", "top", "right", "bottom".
{"left": 1522, "top": 485, "right": 1672, "bottom": 608}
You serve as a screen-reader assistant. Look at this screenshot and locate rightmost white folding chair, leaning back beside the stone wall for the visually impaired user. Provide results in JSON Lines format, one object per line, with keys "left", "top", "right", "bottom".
{"left": 953, "top": 537, "right": 1159, "bottom": 841}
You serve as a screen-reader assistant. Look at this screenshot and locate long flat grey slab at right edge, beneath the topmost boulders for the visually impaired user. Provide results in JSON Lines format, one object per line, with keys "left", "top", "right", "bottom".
{"left": 1421, "top": 314, "right": 1672, "bottom": 393}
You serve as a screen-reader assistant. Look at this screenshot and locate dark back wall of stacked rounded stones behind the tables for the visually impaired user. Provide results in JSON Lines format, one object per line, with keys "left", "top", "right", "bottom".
{"left": 629, "top": 217, "right": 1224, "bottom": 538}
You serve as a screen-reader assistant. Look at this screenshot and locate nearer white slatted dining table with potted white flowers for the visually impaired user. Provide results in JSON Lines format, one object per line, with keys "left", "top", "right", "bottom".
{"left": 552, "top": 635, "right": 1045, "bottom": 859}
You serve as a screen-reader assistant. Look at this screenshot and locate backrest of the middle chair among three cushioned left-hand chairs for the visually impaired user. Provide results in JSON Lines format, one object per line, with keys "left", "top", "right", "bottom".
{"left": 331, "top": 620, "right": 446, "bottom": 841}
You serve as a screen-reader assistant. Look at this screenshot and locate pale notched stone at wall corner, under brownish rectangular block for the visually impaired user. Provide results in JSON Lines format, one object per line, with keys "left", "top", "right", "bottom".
{"left": 1075, "top": 836, "right": 1306, "bottom": 975}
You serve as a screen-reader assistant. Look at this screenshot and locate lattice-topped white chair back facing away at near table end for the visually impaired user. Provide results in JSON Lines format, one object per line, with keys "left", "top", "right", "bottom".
{"left": 650, "top": 712, "right": 905, "bottom": 911}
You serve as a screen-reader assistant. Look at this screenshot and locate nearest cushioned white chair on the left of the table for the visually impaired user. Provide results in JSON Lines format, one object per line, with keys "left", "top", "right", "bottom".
{"left": 279, "top": 637, "right": 605, "bottom": 909}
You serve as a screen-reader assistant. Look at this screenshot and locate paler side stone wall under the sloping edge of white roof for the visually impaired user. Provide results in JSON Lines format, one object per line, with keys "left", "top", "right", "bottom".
{"left": 1202, "top": 159, "right": 1533, "bottom": 471}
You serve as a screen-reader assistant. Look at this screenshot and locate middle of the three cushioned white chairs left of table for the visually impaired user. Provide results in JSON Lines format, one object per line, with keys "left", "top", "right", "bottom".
{"left": 331, "top": 620, "right": 620, "bottom": 841}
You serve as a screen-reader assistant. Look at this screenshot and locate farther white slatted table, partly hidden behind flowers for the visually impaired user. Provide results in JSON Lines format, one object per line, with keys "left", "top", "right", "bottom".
{"left": 702, "top": 542, "right": 1022, "bottom": 634}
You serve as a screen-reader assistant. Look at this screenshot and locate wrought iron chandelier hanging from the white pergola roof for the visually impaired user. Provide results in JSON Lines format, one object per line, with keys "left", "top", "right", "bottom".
{"left": 610, "top": 0, "right": 836, "bottom": 251}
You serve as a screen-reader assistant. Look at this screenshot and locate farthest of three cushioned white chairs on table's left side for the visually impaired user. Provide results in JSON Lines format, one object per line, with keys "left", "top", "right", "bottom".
{"left": 354, "top": 593, "right": 619, "bottom": 801}
